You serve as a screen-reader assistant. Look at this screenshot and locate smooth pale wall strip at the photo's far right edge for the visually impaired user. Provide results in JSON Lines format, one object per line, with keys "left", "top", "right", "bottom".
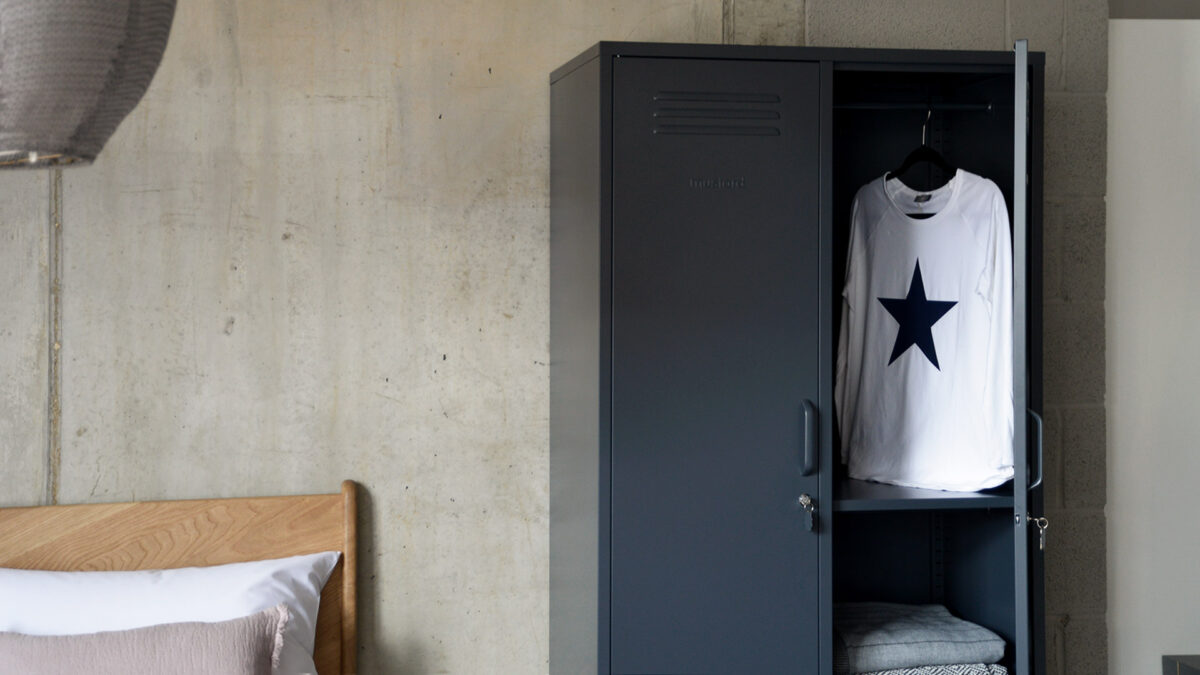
{"left": 1108, "top": 20, "right": 1200, "bottom": 673}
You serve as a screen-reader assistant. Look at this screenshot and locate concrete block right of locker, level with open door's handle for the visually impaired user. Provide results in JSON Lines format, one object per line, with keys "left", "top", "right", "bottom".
{"left": 1062, "top": 406, "right": 1106, "bottom": 509}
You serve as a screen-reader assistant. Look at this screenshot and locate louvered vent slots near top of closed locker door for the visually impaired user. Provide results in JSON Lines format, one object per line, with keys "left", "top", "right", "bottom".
{"left": 654, "top": 91, "right": 782, "bottom": 136}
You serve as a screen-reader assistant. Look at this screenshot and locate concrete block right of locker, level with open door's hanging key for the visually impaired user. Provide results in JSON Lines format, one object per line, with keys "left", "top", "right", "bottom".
{"left": 1045, "top": 509, "right": 1108, "bottom": 612}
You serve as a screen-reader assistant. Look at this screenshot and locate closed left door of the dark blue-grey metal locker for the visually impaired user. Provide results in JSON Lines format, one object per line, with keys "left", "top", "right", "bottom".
{"left": 611, "top": 58, "right": 832, "bottom": 674}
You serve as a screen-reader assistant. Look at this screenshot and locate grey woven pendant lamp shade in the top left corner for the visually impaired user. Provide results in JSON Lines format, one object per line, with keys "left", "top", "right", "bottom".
{"left": 0, "top": 0, "right": 175, "bottom": 168}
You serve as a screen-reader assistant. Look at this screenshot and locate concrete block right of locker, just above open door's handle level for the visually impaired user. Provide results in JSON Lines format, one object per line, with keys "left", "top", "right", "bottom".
{"left": 1043, "top": 303, "right": 1105, "bottom": 406}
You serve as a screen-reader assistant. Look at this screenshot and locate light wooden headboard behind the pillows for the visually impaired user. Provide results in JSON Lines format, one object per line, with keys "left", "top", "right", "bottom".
{"left": 0, "top": 480, "right": 358, "bottom": 675}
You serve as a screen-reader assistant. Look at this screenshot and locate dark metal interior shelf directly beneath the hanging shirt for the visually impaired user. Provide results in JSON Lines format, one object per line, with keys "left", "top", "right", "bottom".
{"left": 833, "top": 478, "right": 1013, "bottom": 512}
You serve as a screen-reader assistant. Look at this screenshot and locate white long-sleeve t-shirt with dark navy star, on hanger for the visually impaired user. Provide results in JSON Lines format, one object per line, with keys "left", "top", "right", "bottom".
{"left": 834, "top": 169, "right": 1013, "bottom": 491}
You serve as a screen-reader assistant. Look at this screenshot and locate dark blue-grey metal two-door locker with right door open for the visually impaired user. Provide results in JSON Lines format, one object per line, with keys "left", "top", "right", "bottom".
{"left": 550, "top": 43, "right": 1044, "bottom": 675}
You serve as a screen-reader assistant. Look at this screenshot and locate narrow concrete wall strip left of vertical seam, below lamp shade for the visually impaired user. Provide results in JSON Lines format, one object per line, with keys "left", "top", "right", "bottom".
{"left": 0, "top": 171, "right": 50, "bottom": 506}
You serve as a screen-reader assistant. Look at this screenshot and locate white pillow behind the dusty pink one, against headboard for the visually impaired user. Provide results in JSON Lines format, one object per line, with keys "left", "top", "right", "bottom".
{"left": 0, "top": 551, "right": 341, "bottom": 675}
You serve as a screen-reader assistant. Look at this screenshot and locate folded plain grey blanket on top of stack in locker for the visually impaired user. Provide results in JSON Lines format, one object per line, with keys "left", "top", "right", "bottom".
{"left": 833, "top": 603, "right": 1004, "bottom": 675}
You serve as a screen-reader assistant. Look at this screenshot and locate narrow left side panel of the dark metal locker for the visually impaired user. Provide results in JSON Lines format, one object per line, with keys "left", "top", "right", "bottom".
{"left": 550, "top": 59, "right": 608, "bottom": 674}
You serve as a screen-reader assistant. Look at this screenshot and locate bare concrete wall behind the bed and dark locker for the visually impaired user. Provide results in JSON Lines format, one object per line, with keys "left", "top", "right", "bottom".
{"left": 0, "top": 0, "right": 1106, "bottom": 674}
